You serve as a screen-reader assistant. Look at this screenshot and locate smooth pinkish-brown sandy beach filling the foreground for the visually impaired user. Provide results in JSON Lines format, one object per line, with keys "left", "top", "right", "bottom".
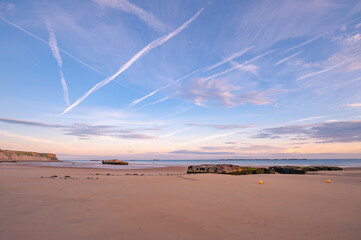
{"left": 0, "top": 165, "right": 361, "bottom": 240}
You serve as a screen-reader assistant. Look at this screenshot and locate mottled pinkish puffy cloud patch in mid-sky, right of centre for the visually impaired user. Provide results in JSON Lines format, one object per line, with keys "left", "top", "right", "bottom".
{"left": 175, "top": 78, "right": 274, "bottom": 108}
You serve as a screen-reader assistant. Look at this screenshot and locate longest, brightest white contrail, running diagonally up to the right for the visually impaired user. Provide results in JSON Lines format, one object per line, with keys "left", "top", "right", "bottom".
{"left": 60, "top": 8, "right": 204, "bottom": 115}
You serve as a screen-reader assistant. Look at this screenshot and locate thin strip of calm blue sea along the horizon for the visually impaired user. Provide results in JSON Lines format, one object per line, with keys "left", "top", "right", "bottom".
{"left": 2, "top": 159, "right": 361, "bottom": 169}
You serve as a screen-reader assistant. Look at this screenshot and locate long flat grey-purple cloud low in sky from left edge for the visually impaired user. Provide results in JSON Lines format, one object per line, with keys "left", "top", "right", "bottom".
{"left": 0, "top": 118, "right": 156, "bottom": 139}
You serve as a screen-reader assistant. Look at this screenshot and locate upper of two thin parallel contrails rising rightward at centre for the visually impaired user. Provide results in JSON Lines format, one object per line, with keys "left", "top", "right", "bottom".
{"left": 125, "top": 46, "right": 253, "bottom": 111}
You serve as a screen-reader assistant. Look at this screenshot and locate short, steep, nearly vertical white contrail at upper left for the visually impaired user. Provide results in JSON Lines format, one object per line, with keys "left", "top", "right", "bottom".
{"left": 46, "top": 22, "right": 70, "bottom": 106}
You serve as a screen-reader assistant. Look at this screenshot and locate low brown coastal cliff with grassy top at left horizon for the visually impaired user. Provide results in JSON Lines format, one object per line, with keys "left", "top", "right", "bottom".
{"left": 0, "top": 149, "right": 59, "bottom": 162}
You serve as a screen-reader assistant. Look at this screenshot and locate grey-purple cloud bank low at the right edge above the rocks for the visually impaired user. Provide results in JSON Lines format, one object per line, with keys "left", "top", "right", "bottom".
{"left": 255, "top": 121, "right": 361, "bottom": 142}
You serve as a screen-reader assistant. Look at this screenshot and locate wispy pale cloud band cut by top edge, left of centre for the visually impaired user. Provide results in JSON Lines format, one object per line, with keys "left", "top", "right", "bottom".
{"left": 93, "top": 0, "right": 167, "bottom": 32}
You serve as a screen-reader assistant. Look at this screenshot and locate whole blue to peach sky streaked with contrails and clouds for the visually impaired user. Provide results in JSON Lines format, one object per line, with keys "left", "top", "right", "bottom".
{"left": 0, "top": 0, "right": 361, "bottom": 160}
